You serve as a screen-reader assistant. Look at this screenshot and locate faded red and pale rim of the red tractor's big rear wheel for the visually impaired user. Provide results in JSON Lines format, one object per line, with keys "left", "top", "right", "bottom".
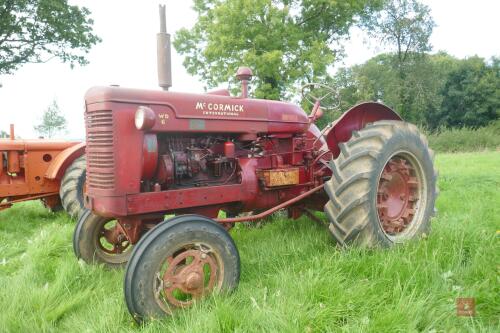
{"left": 376, "top": 151, "right": 427, "bottom": 242}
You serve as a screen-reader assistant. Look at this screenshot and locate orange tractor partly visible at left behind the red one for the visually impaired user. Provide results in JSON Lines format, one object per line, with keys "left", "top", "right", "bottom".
{"left": 0, "top": 125, "right": 85, "bottom": 217}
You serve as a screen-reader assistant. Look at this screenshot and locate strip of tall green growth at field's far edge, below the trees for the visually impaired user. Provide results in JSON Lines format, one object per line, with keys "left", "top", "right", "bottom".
{"left": 427, "top": 120, "right": 500, "bottom": 153}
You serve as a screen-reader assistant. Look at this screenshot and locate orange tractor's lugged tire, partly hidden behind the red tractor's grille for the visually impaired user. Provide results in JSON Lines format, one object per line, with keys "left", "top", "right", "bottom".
{"left": 59, "top": 155, "right": 87, "bottom": 218}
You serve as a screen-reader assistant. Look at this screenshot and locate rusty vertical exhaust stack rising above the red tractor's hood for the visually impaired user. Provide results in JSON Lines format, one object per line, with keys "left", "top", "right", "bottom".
{"left": 156, "top": 5, "right": 172, "bottom": 90}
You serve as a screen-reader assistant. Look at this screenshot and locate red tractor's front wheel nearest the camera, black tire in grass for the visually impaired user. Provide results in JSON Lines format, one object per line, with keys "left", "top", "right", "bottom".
{"left": 124, "top": 215, "right": 240, "bottom": 321}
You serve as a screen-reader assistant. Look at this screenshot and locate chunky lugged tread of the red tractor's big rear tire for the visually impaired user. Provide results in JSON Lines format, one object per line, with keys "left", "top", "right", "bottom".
{"left": 325, "top": 120, "right": 437, "bottom": 247}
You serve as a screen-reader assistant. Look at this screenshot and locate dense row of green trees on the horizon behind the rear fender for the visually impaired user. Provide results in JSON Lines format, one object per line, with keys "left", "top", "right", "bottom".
{"left": 324, "top": 52, "right": 500, "bottom": 130}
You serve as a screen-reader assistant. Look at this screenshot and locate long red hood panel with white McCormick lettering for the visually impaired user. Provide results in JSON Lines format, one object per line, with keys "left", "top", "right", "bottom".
{"left": 85, "top": 87, "right": 308, "bottom": 134}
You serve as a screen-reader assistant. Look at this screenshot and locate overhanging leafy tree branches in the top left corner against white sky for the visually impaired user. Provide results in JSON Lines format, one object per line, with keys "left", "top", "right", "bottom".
{"left": 0, "top": 0, "right": 100, "bottom": 74}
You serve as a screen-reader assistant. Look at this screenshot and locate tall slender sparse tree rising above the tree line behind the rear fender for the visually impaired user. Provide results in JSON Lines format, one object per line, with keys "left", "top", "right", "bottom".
{"left": 366, "top": 0, "right": 435, "bottom": 118}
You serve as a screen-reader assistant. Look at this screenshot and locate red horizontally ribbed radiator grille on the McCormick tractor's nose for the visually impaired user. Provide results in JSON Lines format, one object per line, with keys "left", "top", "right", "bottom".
{"left": 85, "top": 110, "right": 115, "bottom": 190}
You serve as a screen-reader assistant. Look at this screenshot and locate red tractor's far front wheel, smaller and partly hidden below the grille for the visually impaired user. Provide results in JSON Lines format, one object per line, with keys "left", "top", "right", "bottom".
{"left": 73, "top": 209, "right": 132, "bottom": 268}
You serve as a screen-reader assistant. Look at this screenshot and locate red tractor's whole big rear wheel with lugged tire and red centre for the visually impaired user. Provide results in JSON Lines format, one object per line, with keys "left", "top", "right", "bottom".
{"left": 325, "top": 120, "right": 437, "bottom": 247}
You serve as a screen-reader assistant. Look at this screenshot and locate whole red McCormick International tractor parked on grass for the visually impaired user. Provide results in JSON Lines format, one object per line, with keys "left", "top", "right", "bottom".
{"left": 73, "top": 5, "right": 436, "bottom": 320}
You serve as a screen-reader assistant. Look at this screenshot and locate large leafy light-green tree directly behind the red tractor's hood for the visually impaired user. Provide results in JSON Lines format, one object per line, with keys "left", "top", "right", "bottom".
{"left": 174, "top": 0, "right": 383, "bottom": 99}
